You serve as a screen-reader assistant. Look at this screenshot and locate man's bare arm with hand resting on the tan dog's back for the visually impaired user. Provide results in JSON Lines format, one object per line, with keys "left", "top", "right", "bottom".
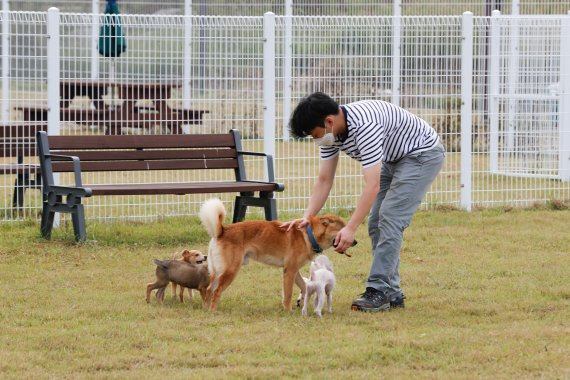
{"left": 281, "top": 155, "right": 338, "bottom": 231}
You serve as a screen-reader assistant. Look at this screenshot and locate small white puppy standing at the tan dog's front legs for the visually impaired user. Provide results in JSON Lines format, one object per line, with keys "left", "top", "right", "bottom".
{"left": 301, "top": 255, "right": 336, "bottom": 317}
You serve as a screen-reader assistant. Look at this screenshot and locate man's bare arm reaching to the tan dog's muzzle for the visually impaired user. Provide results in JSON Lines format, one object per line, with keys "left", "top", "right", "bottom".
{"left": 335, "top": 164, "right": 381, "bottom": 252}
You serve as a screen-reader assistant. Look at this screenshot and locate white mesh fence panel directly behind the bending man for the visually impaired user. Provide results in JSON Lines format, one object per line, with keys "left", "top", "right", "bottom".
{"left": 277, "top": 17, "right": 461, "bottom": 210}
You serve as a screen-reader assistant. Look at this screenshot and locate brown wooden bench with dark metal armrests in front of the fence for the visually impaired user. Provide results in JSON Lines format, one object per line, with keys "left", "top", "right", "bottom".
{"left": 37, "top": 129, "right": 284, "bottom": 241}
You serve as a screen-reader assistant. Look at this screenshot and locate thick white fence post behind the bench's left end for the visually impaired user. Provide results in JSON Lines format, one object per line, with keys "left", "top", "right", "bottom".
{"left": 47, "top": 7, "right": 60, "bottom": 227}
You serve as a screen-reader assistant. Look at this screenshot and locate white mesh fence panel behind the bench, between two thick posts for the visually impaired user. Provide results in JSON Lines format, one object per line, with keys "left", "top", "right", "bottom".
{"left": 55, "top": 14, "right": 263, "bottom": 220}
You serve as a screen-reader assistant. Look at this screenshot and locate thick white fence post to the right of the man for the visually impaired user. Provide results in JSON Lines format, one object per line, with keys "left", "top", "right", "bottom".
{"left": 461, "top": 12, "right": 473, "bottom": 211}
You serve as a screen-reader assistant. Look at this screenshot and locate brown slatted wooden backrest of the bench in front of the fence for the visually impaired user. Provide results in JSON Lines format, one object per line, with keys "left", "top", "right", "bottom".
{"left": 40, "top": 131, "right": 242, "bottom": 178}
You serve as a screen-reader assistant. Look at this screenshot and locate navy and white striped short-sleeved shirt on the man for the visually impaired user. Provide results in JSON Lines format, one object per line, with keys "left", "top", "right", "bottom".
{"left": 320, "top": 100, "right": 439, "bottom": 168}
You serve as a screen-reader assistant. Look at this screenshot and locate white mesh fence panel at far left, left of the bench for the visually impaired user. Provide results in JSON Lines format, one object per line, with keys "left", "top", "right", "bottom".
{"left": 0, "top": 12, "right": 47, "bottom": 220}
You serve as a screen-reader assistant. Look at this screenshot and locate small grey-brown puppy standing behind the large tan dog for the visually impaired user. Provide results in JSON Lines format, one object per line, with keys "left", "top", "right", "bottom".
{"left": 146, "top": 253, "right": 210, "bottom": 305}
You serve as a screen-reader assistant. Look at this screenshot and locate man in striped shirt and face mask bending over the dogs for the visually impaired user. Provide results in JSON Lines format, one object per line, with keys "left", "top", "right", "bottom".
{"left": 284, "top": 92, "right": 445, "bottom": 311}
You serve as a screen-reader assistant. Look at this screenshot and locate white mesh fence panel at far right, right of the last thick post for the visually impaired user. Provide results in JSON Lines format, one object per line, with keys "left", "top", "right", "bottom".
{"left": 473, "top": 17, "right": 570, "bottom": 206}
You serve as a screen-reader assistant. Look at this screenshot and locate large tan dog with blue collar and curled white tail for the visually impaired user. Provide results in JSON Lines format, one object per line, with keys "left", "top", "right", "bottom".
{"left": 200, "top": 199, "right": 356, "bottom": 311}
